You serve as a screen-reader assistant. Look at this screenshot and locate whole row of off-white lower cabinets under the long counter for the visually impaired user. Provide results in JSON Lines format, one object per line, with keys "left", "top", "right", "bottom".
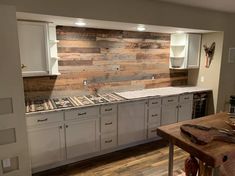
{"left": 27, "top": 94, "right": 196, "bottom": 173}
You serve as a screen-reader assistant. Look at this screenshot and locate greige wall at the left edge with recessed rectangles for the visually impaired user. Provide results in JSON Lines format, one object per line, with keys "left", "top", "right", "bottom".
{"left": 0, "top": 5, "right": 31, "bottom": 176}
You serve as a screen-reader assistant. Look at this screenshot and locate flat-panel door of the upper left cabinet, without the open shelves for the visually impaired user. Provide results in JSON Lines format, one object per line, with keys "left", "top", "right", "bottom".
{"left": 18, "top": 21, "right": 49, "bottom": 76}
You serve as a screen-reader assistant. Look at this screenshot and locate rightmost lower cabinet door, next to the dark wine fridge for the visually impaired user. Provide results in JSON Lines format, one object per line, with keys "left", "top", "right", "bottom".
{"left": 178, "top": 101, "right": 193, "bottom": 122}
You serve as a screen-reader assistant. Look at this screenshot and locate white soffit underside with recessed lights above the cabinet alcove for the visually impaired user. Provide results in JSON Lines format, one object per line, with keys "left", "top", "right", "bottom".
{"left": 16, "top": 12, "right": 213, "bottom": 33}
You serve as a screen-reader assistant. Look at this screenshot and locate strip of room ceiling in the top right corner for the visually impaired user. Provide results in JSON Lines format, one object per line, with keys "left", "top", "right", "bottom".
{"left": 161, "top": 0, "right": 235, "bottom": 13}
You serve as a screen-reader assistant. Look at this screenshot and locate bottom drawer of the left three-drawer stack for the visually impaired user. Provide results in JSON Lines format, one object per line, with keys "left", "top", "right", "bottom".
{"left": 101, "top": 133, "right": 117, "bottom": 150}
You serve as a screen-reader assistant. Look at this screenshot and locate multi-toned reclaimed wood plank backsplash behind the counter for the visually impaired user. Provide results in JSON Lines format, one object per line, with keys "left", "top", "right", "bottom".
{"left": 24, "top": 26, "right": 188, "bottom": 97}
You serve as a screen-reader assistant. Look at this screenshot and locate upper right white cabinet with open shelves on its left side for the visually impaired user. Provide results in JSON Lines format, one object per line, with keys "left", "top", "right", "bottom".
{"left": 170, "top": 34, "right": 201, "bottom": 69}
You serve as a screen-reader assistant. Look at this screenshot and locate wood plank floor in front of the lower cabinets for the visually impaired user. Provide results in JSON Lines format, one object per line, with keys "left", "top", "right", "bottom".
{"left": 34, "top": 141, "right": 188, "bottom": 176}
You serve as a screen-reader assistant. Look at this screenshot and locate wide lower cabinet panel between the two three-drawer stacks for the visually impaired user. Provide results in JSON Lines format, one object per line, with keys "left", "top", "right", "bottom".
{"left": 118, "top": 101, "right": 147, "bottom": 145}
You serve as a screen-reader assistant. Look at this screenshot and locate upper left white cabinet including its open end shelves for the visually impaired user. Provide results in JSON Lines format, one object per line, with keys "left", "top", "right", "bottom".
{"left": 18, "top": 21, "right": 59, "bottom": 77}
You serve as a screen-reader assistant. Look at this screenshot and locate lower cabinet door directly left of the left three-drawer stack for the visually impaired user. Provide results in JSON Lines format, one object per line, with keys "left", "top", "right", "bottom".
{"left": 65, "top": 118, "right": 100, "bottom": 159}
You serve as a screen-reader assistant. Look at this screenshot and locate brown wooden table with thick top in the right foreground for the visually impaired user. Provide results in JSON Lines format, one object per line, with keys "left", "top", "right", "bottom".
{"left": 157, "top": 113, "right": 235, "bottom": 176}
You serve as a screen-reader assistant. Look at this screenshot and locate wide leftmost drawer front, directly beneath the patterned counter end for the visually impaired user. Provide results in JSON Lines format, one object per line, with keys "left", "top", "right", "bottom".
{"left": 26, "top": 112, "right": 64, "bottom": 126}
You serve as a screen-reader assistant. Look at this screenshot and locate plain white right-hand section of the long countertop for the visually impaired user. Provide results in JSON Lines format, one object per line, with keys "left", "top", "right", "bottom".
{"left": 115, "top": 86, "right": 212, "bottom": 99}
